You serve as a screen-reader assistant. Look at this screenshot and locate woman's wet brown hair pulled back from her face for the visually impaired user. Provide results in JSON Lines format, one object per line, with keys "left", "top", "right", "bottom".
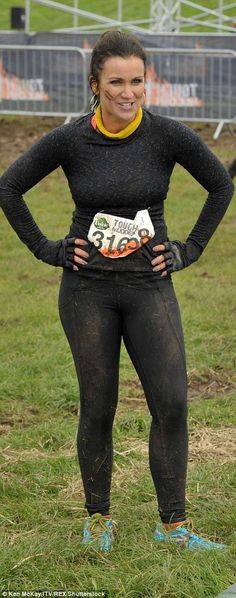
{"left": 89, "top": 31, "right": 147, "bottom": 110}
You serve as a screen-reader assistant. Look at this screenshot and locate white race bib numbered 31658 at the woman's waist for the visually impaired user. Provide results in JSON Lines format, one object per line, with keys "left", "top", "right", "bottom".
{"left": 88, "top": 210, "right": 155, "bottom": 258}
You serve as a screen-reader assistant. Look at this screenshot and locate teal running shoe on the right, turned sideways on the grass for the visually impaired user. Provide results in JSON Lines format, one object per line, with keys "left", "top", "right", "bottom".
{"left": 154, "top": 525, "right": 227, "bottom": 550}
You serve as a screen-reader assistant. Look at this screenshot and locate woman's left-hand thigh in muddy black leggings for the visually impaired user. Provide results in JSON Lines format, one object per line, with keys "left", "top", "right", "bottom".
{"left": 59, "top": 274, "right": 121, "bottom": 411}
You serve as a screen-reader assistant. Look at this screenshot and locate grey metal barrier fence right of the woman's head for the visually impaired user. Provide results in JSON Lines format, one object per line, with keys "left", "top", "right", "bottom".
{"left": 146, "top": 48, "right": 236, "bottom": 139}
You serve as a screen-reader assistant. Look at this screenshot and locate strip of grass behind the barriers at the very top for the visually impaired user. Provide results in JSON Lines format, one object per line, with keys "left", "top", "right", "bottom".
{"left": 0, "top": 0, "right": 235, "bottom": 31}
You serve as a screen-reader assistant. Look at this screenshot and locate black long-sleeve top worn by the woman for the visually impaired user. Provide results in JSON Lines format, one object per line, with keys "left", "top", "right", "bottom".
{"left": 0, "top": 110, "right": 233, "bottom": 273}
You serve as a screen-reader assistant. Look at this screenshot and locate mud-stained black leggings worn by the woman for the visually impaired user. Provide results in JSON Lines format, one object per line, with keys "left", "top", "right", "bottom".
{"left": 59, "top": 272, "right": 188, "bottom": 523}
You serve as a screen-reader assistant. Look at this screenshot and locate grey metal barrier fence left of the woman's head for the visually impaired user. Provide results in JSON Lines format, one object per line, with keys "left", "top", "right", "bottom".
{"left": 0, "top": 45, "right": 88, "bottom": 116}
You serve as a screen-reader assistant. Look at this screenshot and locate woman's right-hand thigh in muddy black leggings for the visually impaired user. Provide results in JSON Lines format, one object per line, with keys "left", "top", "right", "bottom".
{"left": 123, "top": 281, "right": 187, "bottom": 416}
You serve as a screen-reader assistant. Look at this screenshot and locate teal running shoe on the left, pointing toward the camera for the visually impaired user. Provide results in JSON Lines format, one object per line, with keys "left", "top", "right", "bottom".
{"left": 83, "top": 513, "right": 115, "bottom": 552}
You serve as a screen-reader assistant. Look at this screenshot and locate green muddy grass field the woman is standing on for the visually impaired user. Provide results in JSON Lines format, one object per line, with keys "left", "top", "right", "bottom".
{"left": 0, "top": 118, "right": 236, "bottom": 598}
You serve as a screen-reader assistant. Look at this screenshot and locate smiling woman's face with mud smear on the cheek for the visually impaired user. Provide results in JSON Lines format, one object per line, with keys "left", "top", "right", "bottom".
{"left": 92, "top": 56, "right": 145, "bottom": 133}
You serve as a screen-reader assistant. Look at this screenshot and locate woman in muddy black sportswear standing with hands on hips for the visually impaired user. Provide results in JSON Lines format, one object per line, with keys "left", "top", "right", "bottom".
{"left": 0, "top": 31, "right": 233, "bottom": 552}
